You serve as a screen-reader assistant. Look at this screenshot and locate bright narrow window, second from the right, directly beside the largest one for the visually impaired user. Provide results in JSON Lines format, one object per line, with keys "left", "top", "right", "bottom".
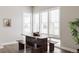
{"left": 40, "top": 11, "right": 48, "bottom": 34}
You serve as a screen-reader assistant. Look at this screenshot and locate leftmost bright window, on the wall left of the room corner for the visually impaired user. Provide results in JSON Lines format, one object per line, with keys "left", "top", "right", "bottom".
{"left": 23, "top": 13, "right": 31, "bottom": 34}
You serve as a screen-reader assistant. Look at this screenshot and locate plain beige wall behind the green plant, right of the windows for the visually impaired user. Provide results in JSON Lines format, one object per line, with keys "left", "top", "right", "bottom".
{"left": 60, "top": 6, "right": 79, "bottom": 51}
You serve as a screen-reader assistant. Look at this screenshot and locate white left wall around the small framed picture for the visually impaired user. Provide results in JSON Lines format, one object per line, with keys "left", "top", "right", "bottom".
{"left": 0, "top": 6, "right": 32, "bottom": 44}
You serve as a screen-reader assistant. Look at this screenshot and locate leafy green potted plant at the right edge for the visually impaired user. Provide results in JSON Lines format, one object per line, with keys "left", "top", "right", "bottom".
{"left": 69, "top": 18, "right": 79, "bottom": 52}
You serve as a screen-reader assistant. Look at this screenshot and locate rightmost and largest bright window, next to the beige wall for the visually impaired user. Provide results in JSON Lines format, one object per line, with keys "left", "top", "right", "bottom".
{"left": 49, "top": 8, "right": 59, "bottom": 35}
